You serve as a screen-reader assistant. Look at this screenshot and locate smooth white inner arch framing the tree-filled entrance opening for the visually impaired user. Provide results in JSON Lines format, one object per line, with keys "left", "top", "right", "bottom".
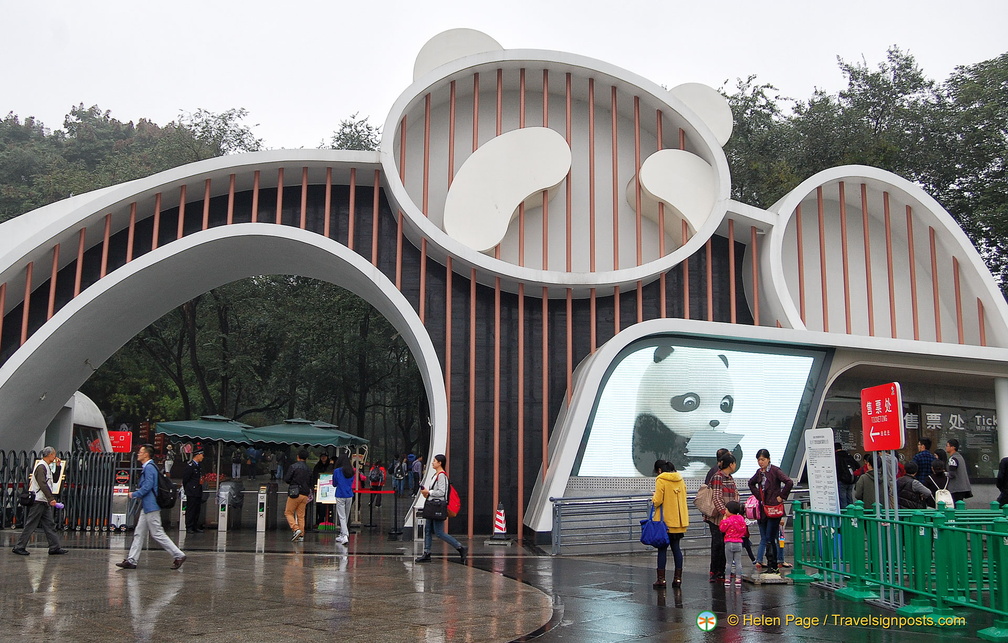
{"left": 0, "top": 224, "right": 448, "bottom": 461}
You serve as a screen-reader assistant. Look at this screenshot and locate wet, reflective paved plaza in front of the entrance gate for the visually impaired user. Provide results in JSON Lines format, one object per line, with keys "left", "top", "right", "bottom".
{"left": 0, "top": 511, "right": 992, "bottom": 643}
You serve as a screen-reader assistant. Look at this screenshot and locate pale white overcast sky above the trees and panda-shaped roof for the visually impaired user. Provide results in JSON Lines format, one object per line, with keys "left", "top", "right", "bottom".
{"left": 7, "top": 0, "right": 1008, "bottom": 148}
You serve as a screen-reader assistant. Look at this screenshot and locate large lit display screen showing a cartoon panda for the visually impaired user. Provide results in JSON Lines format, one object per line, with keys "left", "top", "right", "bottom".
{"left": 572, "top": 337, "right": 827, "bottom": 479}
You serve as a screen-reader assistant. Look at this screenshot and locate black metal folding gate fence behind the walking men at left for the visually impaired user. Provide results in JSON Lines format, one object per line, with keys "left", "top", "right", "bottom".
{"left": 0, "top": 451, "right": 123, "bottom": 531}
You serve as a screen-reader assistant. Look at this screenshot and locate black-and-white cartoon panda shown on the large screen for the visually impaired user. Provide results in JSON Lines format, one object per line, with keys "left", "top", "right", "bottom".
{"left": 633, "top": 346, "right": 742, "bottom": 477}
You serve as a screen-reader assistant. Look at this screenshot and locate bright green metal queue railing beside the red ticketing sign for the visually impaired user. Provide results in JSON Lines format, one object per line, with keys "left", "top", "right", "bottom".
{"left": 790, "top": 502, "right": 1008, "bottom": 641}
